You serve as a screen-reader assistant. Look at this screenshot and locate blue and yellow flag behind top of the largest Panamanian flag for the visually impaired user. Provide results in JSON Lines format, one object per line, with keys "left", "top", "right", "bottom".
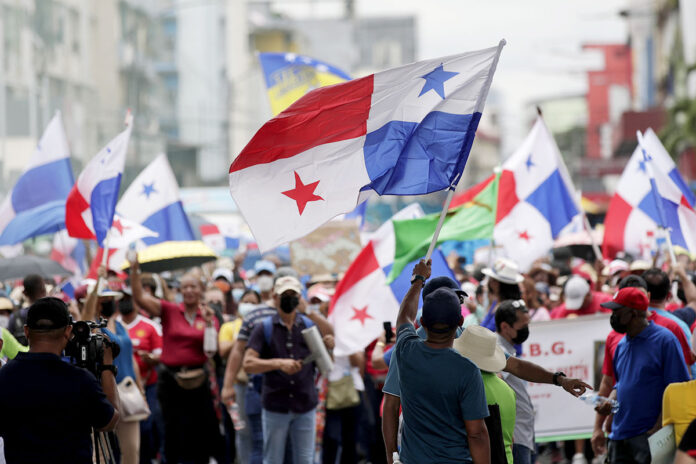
{"left": 259, "top": 53, "right": 351, "bottom": 116}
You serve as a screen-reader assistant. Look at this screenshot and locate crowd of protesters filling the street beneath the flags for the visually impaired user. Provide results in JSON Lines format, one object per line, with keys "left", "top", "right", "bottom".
{"left": 0, "top": 245, "right": 696, "bottom": 464}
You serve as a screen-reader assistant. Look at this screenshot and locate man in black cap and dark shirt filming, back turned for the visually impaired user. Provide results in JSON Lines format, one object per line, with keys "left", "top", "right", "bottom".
{"left": 0, "top": 297, "right": 119, "bottom": 464}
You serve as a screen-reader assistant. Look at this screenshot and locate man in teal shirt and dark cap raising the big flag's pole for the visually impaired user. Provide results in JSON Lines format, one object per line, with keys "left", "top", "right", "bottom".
{"left": 388, "top": 260, "right": 490, "bottom": 464}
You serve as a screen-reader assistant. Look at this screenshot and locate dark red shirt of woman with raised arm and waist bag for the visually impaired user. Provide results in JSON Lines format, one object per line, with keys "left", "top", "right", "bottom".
{"left": 160, "top": 300, "right": 218, "bottom": 367}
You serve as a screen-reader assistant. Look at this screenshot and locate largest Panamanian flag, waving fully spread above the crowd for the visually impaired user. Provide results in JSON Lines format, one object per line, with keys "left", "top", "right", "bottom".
{"left": 229, "top": 41, "right": 505, "bottom": 251}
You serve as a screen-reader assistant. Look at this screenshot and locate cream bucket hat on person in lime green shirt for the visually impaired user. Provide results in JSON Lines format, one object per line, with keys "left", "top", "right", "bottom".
{"left": 454, "top": 325, "right": 507, "bottom": 373}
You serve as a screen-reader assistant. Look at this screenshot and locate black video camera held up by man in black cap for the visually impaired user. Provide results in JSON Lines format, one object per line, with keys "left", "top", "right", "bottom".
{"left": 65, "top": 318, "right": 120, "bottom": 378}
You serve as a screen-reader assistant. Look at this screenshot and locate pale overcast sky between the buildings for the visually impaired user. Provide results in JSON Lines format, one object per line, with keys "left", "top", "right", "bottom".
{"left": 279, "top": 0, "right": 635, "bottom": 156}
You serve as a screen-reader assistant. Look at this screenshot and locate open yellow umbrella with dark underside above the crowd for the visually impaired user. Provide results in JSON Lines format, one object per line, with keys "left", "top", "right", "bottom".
{"left": 121, "top": 241, "right": 218, "bottom": 272}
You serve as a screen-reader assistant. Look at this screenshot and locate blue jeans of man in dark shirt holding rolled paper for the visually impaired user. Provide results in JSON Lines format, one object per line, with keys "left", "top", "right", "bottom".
{"left": 261, "top": 409, "right": 316, "bottom": 464}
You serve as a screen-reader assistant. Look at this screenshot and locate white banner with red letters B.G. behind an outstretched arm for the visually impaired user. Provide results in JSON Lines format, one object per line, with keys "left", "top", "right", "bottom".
{"left": 522, "top": 314, "right": 611, "bottom": 441}
